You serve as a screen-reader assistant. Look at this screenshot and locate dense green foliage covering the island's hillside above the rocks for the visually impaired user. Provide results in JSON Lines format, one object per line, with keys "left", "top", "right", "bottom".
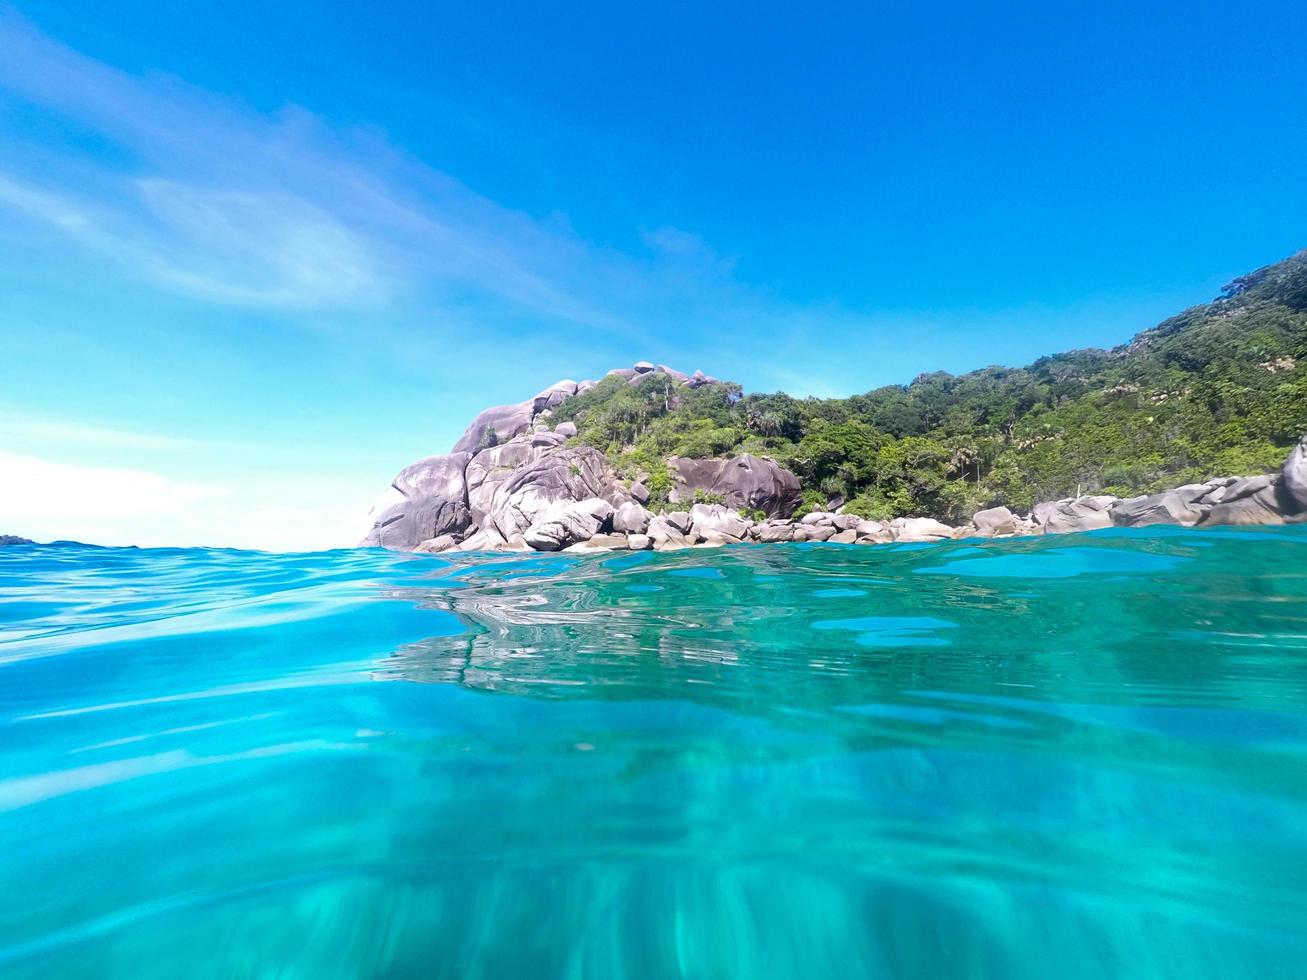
{"left": 553, "top": 252, "right": 1307, "bottom": 520}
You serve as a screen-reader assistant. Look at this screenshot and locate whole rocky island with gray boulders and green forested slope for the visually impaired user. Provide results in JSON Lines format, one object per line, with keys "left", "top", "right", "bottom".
{"left": 361, "top": 252, "right": 1307, "bottom": 551}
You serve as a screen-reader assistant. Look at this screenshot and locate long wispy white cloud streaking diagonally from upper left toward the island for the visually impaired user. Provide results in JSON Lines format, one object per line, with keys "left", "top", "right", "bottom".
{"left": 0, "top": 9, "right": 867, "bottom": 350}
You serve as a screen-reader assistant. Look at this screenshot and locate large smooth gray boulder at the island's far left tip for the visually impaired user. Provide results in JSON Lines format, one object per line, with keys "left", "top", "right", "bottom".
{"left": 359, "top": 452, "right": 472, "bottom": 551}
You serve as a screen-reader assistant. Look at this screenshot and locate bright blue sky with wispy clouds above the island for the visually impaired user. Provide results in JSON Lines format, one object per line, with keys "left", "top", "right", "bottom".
{"left": 0, "top": 0, "right": 1307, "bottom": 549}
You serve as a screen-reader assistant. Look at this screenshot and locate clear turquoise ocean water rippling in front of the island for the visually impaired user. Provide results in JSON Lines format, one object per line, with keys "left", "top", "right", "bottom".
{"left": 0, "top": 527, "right": 1307, "bottom": 980}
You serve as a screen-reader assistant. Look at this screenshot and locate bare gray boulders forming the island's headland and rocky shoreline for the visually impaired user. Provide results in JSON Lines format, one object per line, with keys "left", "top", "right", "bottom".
{"left": 361, "top": 362, "right": 1307, "bottom": 553}
